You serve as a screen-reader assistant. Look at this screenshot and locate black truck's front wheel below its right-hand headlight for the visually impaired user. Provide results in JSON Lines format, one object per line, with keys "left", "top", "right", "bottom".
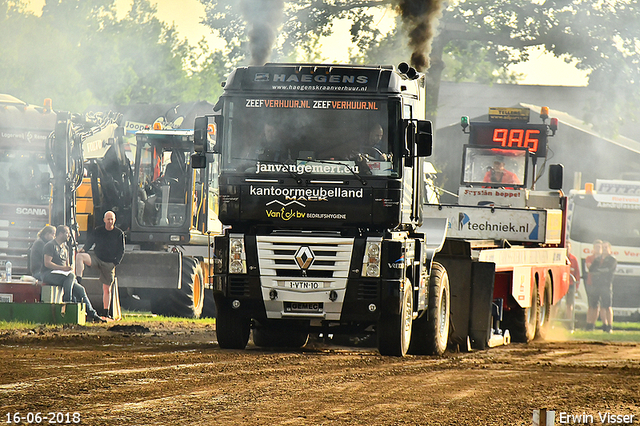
{"left": 377, "top": 279, "right": 413, "bottom": 356}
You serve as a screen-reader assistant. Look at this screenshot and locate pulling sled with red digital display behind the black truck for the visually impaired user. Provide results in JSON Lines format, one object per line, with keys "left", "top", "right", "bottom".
{"left": 432, "top": 107, "right": 570, "bottom": 347}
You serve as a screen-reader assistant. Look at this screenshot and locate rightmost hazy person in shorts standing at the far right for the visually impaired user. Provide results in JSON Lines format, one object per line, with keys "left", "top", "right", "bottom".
{"left": 589, "top": 241, "right": 618, "bottom": 333}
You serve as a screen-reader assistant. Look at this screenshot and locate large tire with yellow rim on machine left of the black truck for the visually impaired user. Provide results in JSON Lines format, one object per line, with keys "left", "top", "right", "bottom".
{"left": 151, "top": 256, "right": 204, "bottom": 318}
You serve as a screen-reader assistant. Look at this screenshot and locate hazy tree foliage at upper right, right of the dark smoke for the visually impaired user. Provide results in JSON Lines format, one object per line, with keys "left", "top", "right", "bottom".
{"left": 441, "top": 0, "right": 640, "bottom": 135}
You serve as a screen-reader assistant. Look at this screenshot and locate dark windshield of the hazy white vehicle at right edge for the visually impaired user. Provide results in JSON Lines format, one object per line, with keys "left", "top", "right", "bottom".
{"left": 570, "top": 197, "right": 640, "bottom": 247}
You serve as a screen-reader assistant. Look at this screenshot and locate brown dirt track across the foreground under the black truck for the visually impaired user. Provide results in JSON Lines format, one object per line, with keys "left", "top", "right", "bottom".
{"left": 0, "top": 323, "right": 640, "bottom": 425}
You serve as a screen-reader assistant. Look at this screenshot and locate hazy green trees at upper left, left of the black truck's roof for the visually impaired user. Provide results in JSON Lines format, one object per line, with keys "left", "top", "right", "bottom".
{"left": 0, "top": 0, "right": 228, "bottom": 112}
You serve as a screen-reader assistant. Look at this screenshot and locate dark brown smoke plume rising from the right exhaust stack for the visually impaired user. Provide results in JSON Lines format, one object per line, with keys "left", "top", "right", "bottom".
{"left": 398, "top": 0, "right": 444, "bottom": 71}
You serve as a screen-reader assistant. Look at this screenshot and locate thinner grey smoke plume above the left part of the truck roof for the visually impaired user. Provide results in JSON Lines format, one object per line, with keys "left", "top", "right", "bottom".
{"left": 240, "top": 0, "right": 284, "bottom": 65}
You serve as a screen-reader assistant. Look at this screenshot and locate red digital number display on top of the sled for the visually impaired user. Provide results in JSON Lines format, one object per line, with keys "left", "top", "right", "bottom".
{"left": 469, "top": 122, "right": 547, "bottom": 157}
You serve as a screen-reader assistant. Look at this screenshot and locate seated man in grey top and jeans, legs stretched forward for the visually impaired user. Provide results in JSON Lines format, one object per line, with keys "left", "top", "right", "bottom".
{"left": 42, "top": 225, "right": 107, "bottom": 322}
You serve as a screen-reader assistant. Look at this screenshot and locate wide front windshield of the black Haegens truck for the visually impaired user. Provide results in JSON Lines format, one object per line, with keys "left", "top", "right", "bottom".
{"left": 221, "top": 97, "right": 400, "bottom": 177}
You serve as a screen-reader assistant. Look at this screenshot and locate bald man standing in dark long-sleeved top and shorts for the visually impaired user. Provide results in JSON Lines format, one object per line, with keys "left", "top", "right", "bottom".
{"left": 76, "top": 211, "right": 124, "bottom": 316}
